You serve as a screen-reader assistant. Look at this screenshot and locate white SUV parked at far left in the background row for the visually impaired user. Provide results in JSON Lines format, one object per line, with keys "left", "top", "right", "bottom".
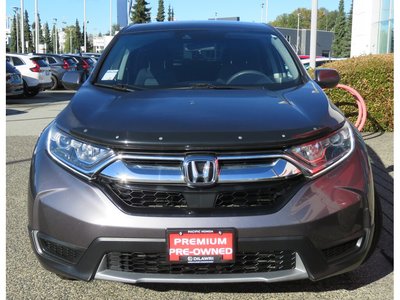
{"left": 7, "top": 53, "right": 52, "bottom": 97}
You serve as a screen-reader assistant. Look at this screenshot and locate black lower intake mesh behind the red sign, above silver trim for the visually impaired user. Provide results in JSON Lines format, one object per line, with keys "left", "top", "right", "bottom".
{"left": 107, "top": 251, "right": 296, "bottom": 274}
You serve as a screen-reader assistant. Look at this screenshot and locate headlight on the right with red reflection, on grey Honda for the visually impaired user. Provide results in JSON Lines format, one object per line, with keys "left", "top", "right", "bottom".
{"left": 289, "top": 122, "right": 354, "bottom": 175}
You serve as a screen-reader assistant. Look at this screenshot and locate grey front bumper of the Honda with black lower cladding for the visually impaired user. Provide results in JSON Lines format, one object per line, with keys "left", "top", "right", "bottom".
{"left": 28, "top": 130, "right": 374, "bottom": 283}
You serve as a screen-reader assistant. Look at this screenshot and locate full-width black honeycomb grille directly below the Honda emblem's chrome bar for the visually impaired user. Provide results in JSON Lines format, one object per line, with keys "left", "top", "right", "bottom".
{"left": 98, "top": 177, "right": 304, "bottom": 216}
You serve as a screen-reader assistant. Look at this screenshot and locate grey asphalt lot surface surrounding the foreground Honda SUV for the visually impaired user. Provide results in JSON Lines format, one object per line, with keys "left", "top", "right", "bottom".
{"left": 6, "top": 91, "right": 394, "bottom": 300}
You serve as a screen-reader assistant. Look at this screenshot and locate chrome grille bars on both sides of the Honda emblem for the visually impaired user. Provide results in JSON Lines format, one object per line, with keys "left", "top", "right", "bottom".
{"left": 100, "top": 155, "right": 301, "bottom": 184}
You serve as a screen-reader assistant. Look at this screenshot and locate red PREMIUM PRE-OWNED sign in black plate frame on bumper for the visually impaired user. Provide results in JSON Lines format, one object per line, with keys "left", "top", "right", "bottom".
{"left": 167, "top": 229, "right": 235, "bottom": 264}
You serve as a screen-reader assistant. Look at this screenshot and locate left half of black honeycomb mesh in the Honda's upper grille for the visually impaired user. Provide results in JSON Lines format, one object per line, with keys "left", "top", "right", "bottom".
{"left": 109, "top": 183, "right": 187, "bottom": 207}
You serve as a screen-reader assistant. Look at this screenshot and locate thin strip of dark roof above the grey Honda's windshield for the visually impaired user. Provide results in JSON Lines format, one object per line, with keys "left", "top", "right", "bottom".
{"left": 120, "top": 20, "right": 276, "bottom": 34}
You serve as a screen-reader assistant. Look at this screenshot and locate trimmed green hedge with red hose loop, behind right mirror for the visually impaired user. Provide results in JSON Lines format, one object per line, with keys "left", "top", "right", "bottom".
{"left": 323, "top": 54, "right": 394, "bottom": 132}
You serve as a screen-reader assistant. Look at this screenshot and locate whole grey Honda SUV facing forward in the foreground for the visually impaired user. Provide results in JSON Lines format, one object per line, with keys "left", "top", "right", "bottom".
{"left": 28, "top": 21, "right": 381, "bottom": 284}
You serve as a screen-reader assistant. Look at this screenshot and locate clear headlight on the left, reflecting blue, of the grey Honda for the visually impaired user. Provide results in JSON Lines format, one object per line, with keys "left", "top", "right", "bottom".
{"left": 47, "top": 125, "right": 114, "bottom": 176}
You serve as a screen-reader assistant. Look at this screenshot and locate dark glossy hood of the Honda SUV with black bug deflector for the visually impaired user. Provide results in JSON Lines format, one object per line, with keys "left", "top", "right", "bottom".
{"left": 56, "top": 81, "right": 345, "bottom": 150}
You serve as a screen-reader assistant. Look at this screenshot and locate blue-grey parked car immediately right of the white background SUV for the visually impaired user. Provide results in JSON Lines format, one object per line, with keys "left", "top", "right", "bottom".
{"left": 39, "top": 54, "right": 77, "bottom": 90}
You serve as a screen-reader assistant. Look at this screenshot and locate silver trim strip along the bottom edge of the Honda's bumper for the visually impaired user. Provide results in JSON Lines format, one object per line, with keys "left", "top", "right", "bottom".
{"left": 95, "top": 253, "right": 308, "bottom": 284}
